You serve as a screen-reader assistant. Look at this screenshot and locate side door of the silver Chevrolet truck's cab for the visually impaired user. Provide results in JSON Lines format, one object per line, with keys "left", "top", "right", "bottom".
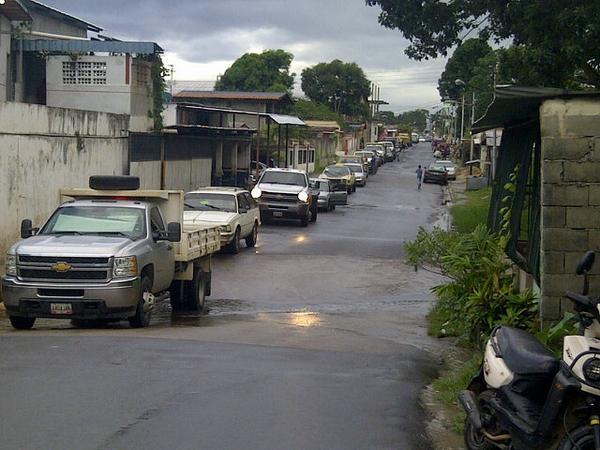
{"left": 150, "top": 206, "right": 175, "bottom": 292}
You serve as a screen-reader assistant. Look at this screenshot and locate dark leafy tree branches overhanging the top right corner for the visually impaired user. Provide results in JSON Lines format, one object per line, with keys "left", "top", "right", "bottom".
{"left": 366, "top": 0, "right": 600, "bottom": 87}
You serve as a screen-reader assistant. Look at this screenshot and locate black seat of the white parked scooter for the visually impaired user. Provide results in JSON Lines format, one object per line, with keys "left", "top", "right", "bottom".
{"left": 494, "top": 327, "right": 560, "bottom": 375}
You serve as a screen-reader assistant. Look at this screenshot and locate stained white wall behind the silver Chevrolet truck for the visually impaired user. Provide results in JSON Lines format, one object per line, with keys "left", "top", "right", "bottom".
{"left": 0, "top": 102, "right": 128, "bottom": 280}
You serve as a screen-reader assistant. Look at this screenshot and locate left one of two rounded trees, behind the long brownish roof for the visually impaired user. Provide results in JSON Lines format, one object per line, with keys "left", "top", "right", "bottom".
{"left": 215, "top": 50, "right": 295, "bottom": 92}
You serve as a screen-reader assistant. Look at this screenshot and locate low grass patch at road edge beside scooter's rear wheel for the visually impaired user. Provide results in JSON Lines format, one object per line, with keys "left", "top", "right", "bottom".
{"left": 433, "top": 354, "right": 481, "bottom": 434}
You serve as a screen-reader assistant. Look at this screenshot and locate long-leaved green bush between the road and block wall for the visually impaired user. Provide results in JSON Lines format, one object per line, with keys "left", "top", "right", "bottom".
{"left": 406, "top": 225, "right": 537, "bottom": 346}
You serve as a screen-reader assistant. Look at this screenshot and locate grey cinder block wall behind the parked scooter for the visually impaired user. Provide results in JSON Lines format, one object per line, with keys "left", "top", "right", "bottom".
{"left": 540, "top": 98, "right": 600, "bottom": 321}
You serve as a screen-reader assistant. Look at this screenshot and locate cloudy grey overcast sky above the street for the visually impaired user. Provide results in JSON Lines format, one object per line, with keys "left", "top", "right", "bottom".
{"left": 47, "top": 0, "right": 445, "bottom": 112}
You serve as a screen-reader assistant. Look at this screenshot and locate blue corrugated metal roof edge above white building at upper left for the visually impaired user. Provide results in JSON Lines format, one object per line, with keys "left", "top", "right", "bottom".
{"left": 12, "top": 39, "right": 163, "bottom": 55}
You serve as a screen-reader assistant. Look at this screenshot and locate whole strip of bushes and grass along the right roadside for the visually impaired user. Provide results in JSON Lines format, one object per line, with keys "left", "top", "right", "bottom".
{"left": 406, "top": 185, "right": 573, "bottom": 433}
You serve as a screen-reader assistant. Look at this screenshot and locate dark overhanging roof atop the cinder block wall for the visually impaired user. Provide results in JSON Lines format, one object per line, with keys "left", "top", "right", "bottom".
{"left": 473, "top": 86, "right": 600, "bottom": 133}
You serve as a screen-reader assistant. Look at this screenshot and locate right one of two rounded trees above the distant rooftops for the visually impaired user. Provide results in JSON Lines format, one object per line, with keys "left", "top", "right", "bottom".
{"left": 302, "top": 59, "right": 371, "bottom": 118}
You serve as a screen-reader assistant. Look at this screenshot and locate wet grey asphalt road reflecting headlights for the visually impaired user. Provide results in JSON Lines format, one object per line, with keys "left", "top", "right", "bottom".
{"left": 0, "top": 144, "right": 443, "bottom": 449}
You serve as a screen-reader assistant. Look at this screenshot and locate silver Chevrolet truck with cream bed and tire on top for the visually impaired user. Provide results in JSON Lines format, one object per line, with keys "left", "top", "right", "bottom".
{"left": 2, "top": 176, "right": 220, "bottom": 329}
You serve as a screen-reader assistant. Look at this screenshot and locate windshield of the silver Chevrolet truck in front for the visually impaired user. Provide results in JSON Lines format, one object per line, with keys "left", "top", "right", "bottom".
{"left": 40, "top": 206, "right": 146, "bottom": 239}
